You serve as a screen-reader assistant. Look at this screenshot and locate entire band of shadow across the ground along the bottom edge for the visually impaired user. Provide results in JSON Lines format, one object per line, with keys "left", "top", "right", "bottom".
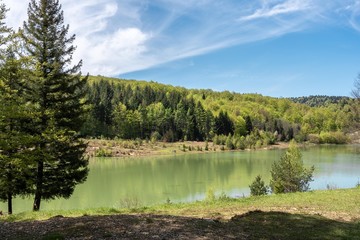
{"left": 0, "top": 211, "right": 360, "bottom": 240}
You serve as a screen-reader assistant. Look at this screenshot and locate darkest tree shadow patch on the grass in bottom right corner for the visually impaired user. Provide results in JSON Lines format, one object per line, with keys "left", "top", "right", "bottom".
{"left": 228, "top": 211, "right": 360, "bottom": 240}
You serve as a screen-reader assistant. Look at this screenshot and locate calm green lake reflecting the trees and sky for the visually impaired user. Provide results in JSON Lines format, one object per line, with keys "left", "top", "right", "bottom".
{"left": 0, "top": 145, "right": 360, "bottom": 213}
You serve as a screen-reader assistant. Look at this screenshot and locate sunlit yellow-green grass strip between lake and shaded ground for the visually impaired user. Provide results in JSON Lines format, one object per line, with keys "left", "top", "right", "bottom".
{"left": 0, "top": 187, "right": 360, "bottom": 222}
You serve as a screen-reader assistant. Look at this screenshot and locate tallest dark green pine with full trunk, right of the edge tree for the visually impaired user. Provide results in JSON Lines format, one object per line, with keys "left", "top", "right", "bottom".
{"left": 22, "top": 0, "right": 88, "bottom": 211}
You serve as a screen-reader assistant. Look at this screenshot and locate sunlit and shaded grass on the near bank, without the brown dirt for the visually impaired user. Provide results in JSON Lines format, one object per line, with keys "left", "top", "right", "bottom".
{"left": 0, "top": 187, "right": 360, "bottom": 240}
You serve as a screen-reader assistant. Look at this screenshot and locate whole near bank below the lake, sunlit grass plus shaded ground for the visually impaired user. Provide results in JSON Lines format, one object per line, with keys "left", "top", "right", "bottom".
{"left": 0, "top": 187, "right": 360, "bottom": 240}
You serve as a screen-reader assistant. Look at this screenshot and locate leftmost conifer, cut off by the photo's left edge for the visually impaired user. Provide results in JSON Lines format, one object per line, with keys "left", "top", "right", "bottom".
{"left": 0, "top": 4, "right": 33, "bottom": 214}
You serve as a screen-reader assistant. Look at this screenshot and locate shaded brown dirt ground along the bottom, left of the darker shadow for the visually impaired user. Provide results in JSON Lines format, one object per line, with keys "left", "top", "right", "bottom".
{"left": 0, "top": 215, "right": 246, "bottom": 239}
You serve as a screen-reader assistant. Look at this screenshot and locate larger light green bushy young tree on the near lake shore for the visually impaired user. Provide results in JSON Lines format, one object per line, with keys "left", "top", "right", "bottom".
{"left": 270, "top": 141, "right": 314, "bottom": 193}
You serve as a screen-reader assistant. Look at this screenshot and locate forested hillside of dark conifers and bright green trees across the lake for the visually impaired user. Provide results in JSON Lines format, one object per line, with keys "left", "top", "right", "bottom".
{"left": 81, "top": 76, "right": 353, "bottom": 148}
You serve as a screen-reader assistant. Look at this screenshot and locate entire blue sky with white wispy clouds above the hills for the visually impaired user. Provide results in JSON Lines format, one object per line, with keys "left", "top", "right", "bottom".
{"left": 3, "top": 0, "right": 360, "bottom": 97}
